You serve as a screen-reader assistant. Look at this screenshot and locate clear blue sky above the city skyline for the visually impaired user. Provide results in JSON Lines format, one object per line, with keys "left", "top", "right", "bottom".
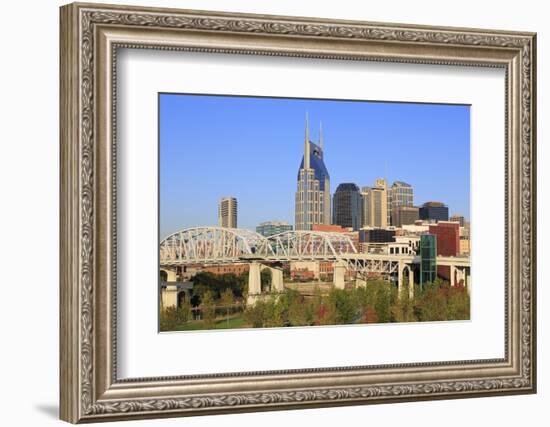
{"left": 159, "top": 94, "right": 470, "bottom": 238}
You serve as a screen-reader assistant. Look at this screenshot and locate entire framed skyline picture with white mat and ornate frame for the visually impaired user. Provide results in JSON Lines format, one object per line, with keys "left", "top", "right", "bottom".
{"left": 60, "top": 4, "right": 536, "bottom": 423}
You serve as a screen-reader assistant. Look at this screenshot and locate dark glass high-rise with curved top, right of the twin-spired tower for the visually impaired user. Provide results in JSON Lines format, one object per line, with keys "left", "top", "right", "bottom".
{"left": 332, "top": 182, "right": 362, "bottom": 230}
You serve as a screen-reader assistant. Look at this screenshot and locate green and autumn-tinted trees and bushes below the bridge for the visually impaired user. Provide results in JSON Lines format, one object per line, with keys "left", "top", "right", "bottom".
{"left": 160, "top": 273, "right": 470, "bottom": 331}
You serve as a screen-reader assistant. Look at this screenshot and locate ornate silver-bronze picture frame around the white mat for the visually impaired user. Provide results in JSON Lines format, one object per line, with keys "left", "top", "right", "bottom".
{"left": 60, "top": 4, "right": 536, "bottom": 423}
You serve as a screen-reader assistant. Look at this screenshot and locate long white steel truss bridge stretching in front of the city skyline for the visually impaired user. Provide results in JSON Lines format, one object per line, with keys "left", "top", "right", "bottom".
{"left": 160, "top": 227, "right": 470, "bottom": 287}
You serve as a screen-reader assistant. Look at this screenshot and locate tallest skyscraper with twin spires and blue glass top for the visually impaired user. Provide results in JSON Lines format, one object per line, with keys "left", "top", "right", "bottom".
{"left": 294, "top": 114, "right": 330, "bottom": 230}
